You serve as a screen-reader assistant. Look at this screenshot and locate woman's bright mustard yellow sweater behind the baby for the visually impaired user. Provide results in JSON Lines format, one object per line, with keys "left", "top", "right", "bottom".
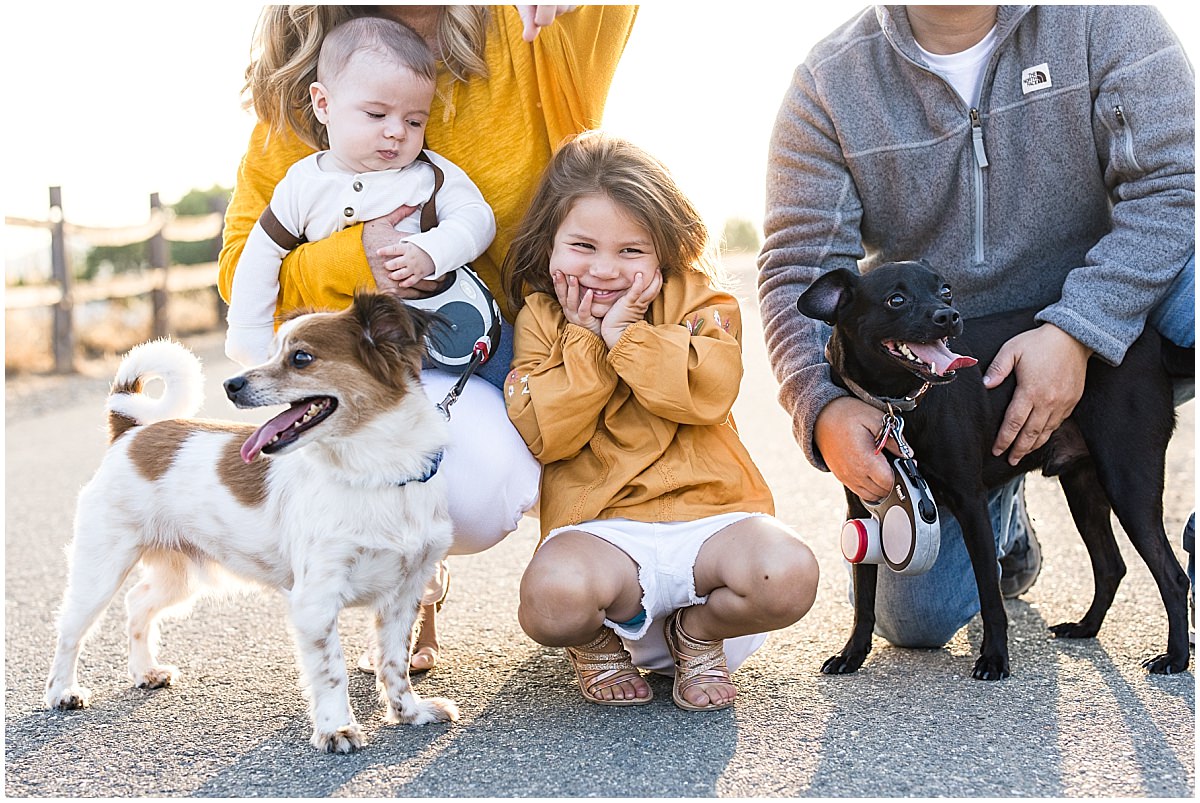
{"left": 220, "top": 6, "right": 637, "bottom": 319}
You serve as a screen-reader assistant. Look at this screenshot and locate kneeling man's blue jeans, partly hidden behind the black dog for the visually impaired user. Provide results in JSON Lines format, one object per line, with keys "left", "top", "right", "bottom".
{"left": 875, "top": 254, "right": 1195, "bottom": 647}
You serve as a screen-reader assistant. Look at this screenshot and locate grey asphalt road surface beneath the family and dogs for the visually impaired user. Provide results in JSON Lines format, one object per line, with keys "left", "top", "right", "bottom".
{"left": 4, "top": 253, "right": 1196, "bottom": 798}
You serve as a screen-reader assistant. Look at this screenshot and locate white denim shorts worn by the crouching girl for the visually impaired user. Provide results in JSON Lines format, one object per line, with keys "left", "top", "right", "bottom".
{"left": 542, "top": 513, "right": 767, "bottom": 675}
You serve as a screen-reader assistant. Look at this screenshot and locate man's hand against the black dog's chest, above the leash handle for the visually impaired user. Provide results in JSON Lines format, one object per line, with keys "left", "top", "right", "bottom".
{"left": 812, "top": 396, "right": 900, "bottom": 502}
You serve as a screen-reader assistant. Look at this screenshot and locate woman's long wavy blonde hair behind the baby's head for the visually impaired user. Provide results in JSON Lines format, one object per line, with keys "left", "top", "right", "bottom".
{"left": 242, "top": 6, "right": 491, "bottom": 149}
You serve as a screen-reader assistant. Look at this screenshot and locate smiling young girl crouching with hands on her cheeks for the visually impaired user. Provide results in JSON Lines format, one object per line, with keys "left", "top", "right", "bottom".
{"left": 504, "top": 132, "right": 817, "bottom": 711}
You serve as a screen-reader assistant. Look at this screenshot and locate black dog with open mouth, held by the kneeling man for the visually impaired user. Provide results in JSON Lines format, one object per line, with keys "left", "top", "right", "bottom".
{"left": 797, "top": 262, "right": 1188, "bottom": 681}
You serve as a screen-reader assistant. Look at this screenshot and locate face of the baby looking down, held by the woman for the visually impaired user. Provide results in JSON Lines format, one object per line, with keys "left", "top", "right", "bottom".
{"left": 310, "top": 52, "right": 433, "bottom": 173}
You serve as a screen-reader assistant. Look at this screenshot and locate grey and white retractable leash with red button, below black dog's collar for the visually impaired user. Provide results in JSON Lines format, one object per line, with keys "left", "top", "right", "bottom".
{"left": 841, "top": 402, "right": 941, "bottom": 575}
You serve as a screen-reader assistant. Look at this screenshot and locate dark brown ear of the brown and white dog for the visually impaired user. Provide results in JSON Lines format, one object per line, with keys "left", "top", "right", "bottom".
{"left": 353, "top": 290, "right": 436, "bottom": 389}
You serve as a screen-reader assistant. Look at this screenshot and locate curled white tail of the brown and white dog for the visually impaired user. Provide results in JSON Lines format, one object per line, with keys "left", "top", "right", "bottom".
{"left": 108, "top": 338, "right": 204, "bottom": 443}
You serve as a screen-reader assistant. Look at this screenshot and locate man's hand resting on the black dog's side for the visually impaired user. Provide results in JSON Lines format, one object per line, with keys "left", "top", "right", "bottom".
{"left": 983, "top": 324, "right": 1092, "bottom": 466}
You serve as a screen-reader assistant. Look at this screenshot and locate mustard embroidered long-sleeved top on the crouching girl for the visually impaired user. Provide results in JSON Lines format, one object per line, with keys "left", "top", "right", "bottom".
{"left": 504, "top": 271, "right": 774, "bottom": 538}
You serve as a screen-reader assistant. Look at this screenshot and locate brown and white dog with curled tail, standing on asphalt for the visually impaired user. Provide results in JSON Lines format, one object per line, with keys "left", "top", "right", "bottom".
{"left": 46, "top": 294, "right": 458, "bottom": 753}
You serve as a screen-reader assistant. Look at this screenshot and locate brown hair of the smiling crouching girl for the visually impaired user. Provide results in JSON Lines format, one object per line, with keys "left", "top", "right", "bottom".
{"left": 503, "top": 131, "right": 724, "bottom": 311}
